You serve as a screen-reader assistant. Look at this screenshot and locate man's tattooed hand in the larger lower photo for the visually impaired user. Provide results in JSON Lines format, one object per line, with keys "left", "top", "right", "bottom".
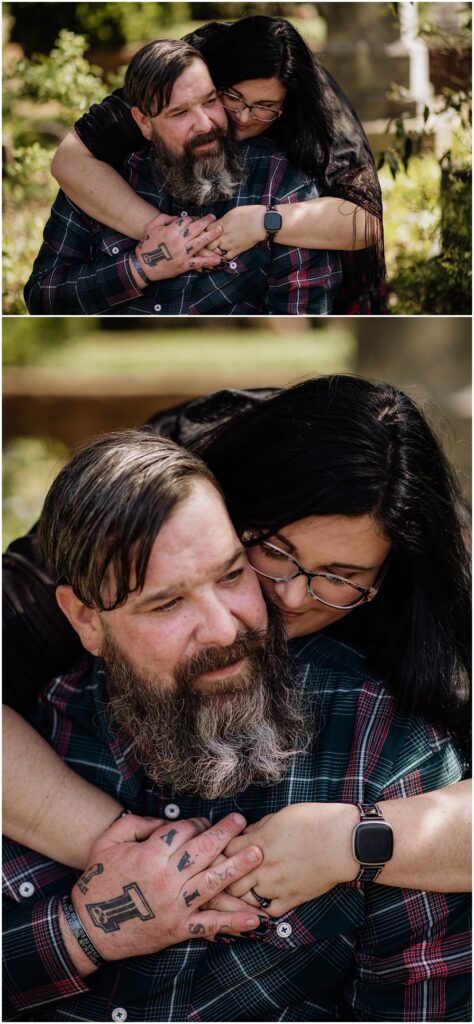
{"left": 61, "top": 814, "right": 262, "bottom": 974}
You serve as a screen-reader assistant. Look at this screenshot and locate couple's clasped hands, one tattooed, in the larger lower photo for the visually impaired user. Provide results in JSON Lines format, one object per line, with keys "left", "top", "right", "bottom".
{"left": 66, "top": 804, "right": 350, "bottom": 959}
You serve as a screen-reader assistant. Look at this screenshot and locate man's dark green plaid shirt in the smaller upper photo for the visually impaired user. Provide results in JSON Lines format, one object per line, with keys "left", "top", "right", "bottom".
{"left": 25, "top": 139, "right": 341, "bottom": 316}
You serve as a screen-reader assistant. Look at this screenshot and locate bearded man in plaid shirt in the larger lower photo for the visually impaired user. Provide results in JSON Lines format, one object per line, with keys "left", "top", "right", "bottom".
{"left": 4, "top": 432, "right": 470, "bottom": 1021}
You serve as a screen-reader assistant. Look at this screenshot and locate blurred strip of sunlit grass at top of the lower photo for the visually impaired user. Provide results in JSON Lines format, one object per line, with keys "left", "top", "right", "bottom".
{"left": 4, "top": 317, "right": 355, "bottom": 383}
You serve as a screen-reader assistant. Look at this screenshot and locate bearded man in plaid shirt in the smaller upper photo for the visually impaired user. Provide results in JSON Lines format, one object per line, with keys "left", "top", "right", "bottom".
{"left": 25, "top": 41, "right": 341, "bottom": 315}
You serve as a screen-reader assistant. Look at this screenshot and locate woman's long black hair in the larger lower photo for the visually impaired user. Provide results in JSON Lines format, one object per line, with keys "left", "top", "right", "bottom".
{"left": 193, "top": 375, "right": 470, "bottom": 744}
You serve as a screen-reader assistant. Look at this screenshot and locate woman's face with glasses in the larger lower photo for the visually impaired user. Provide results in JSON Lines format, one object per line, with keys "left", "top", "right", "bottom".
{"left": 248, "top": 515, "right": 390, "bottom": 637}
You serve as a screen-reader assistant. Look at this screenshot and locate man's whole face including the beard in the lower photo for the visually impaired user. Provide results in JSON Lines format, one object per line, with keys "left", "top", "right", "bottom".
{"left": 94, "top": 479, "right": 308, "bottom": 799}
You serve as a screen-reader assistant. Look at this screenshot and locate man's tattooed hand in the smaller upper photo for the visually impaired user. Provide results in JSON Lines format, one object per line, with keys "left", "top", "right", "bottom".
{"left": 130, "top": 213, "right": 222, "bottom": 287}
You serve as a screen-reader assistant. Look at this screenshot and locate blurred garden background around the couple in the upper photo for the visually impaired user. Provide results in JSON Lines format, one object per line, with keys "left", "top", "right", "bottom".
{"left": 2, "top": 0, "right": 472, "bottom": 315}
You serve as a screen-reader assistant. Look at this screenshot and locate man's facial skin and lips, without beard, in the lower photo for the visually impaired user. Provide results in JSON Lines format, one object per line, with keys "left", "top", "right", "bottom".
{"left": 99, "top": 478, "right": 267, "bottom": 693}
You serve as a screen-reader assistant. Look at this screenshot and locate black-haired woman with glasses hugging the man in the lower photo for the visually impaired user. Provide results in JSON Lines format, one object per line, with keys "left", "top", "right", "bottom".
{"left": 4, "top": 375, "right": 470, "bottom": 914}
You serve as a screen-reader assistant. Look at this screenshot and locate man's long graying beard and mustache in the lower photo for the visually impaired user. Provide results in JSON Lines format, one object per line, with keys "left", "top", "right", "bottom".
{"left": 103, "top": 606, "right": 313, "bottom": 800}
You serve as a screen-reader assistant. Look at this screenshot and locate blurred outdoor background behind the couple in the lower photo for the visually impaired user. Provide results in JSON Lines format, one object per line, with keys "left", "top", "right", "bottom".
{"left": 3, "top": 316, "right": 471, "bottom": 547}
